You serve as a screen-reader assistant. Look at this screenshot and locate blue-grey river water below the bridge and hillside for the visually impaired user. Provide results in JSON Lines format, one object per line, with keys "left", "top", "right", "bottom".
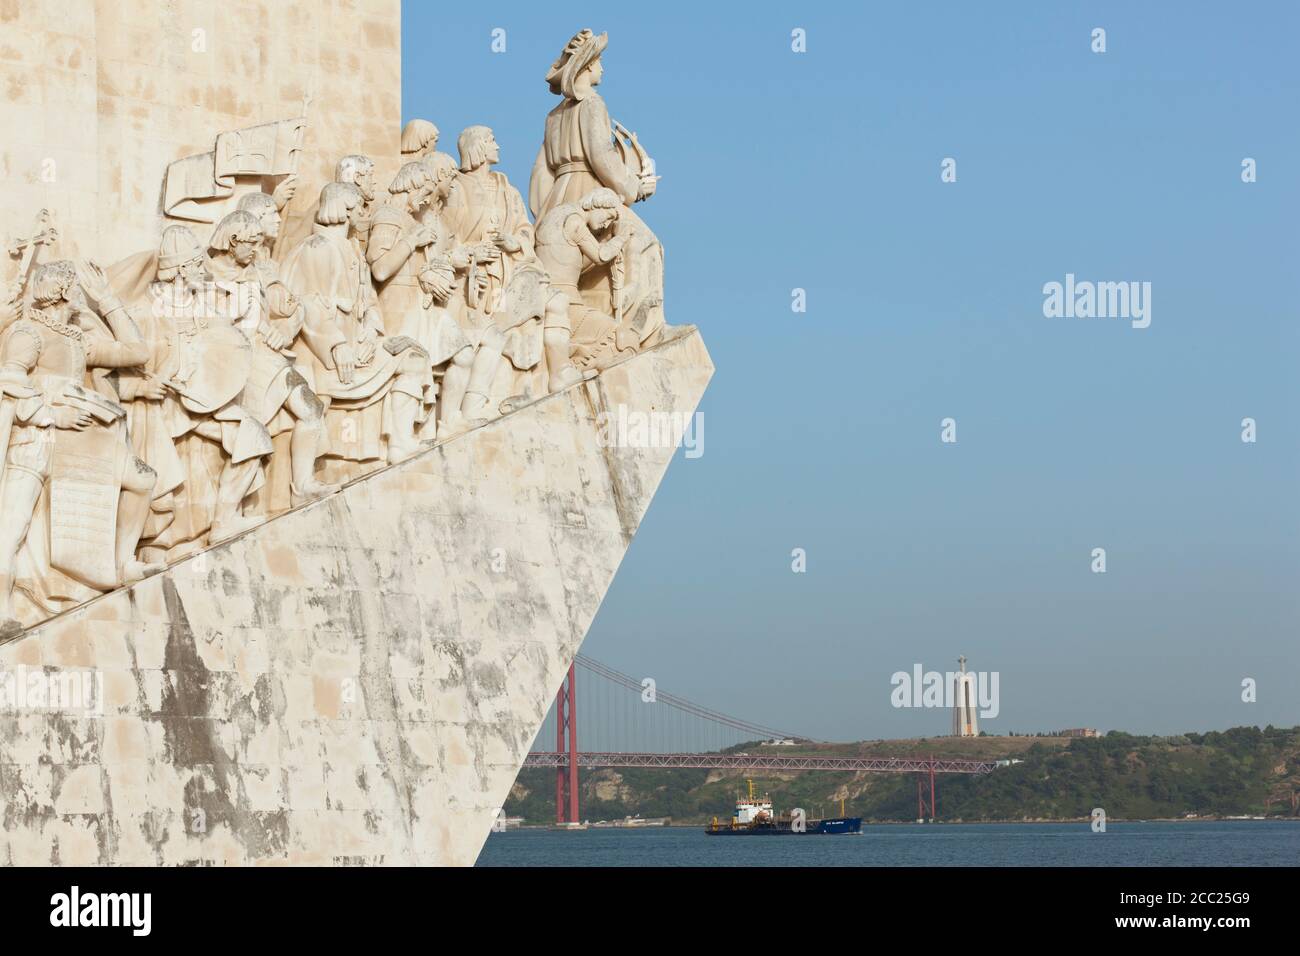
{"left": 477, "top": 821, "right": 1300, "bottom": 866}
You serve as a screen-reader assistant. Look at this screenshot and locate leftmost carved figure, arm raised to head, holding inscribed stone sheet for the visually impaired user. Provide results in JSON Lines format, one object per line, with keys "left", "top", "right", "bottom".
{"left": 0, "top": 260, "right": 161, "bottom": 631}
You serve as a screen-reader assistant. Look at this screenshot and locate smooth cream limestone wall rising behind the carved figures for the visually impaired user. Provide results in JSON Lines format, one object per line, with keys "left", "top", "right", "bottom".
{"left": 0, "top": 0, "right": 402, "bottom": 278}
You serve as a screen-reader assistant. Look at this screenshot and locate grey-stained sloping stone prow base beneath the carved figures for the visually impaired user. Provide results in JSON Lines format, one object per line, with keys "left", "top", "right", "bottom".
{"left": 0, "top": 329, "right": 712, "bottom": 865}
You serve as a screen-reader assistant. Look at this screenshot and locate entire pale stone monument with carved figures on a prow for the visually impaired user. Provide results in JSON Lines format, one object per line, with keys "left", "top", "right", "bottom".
{"left": 0, "top": 11, "right": 712, "bottom": 865}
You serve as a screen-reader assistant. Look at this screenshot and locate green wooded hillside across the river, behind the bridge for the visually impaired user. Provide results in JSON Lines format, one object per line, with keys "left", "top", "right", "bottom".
{"left": 504, "top": 726, "right": 1300, "bottom": 823}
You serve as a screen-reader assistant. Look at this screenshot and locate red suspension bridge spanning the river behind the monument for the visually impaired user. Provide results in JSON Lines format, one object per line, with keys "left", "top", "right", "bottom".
{"left": 524, "top": 654, "right": 995, "bottom": 823}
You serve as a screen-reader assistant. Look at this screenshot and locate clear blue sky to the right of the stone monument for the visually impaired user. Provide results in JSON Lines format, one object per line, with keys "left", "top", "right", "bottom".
{"left": 403, "top": 0, "right": 1300, "bottom": 740}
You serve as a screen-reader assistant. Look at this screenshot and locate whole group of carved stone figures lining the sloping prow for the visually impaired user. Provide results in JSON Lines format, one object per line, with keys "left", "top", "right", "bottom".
{"left": 0, "top": 30, "right": 666, "bottom": 640}
